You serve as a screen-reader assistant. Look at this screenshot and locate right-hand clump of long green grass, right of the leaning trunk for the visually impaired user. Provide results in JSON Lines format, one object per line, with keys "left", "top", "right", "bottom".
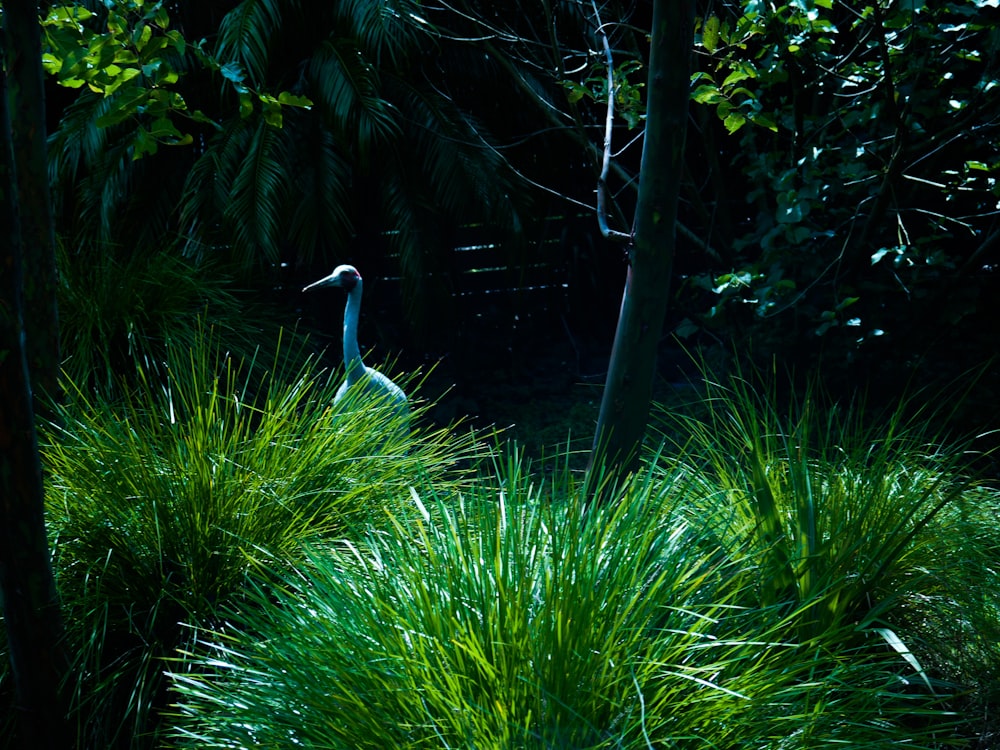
{"left": 660, "top": 370, "right": 1000, "bottom": 747}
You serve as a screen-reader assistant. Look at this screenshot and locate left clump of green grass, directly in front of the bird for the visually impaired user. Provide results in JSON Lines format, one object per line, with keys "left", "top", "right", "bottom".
{"left": 43, "top": 332, "right": 475, "bottom": 747}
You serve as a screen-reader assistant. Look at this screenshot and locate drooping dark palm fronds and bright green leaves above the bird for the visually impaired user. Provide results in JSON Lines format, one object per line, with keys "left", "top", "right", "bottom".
{"left": 41, "top": 0, "right": 518, "bottom": 301}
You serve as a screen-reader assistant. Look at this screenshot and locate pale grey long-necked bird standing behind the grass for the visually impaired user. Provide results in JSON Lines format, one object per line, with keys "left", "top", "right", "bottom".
{"left": 302, "top": 265, "right": 409, "bottom": 432}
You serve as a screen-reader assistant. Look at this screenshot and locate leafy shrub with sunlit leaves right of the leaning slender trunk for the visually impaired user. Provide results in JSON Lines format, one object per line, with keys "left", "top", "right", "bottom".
{"left": 688, "top": 2, "right": 1000, "bottom": 384}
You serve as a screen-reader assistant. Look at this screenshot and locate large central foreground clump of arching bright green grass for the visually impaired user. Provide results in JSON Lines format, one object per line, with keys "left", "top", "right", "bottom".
{"left": 166, "top": 440, "right": 976, "bottom": 750}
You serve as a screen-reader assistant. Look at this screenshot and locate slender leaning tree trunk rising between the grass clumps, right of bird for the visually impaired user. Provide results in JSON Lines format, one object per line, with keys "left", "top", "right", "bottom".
{"left": 590, "top": 0, "right": 694, "bottom": 476}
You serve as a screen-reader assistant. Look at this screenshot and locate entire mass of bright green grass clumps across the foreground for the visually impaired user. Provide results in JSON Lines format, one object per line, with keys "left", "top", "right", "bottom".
{"left": 3, "top": 332, "right": 1000, "bottom": 750}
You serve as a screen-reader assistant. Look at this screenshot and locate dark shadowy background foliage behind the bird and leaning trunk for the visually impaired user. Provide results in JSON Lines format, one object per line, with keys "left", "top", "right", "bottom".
{"left": 39, "top": 0, "right": 1000, "bottom": 446}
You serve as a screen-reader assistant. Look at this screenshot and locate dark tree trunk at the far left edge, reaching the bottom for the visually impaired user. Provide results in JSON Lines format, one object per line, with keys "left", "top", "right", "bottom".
{"left": 0, "top": 0, "right": 73, "bottom": 749}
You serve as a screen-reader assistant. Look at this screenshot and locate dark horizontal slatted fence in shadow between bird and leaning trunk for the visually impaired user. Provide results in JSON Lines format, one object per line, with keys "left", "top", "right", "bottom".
{"left": 365, "top": 216, "right": 625, "bottom": 376}
